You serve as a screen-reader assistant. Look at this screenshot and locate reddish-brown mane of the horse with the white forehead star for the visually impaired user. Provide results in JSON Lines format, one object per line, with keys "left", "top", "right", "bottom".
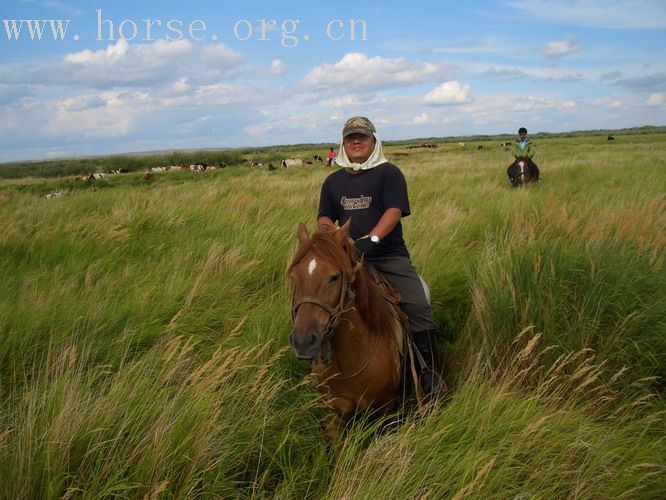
{"left": 289, "top": 230, "right": 397, "bottom": 335}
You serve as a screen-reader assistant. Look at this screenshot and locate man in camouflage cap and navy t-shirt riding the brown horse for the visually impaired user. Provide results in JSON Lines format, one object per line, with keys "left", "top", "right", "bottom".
{"left": 317, "top": 116, "right": 442, "bottom": 397}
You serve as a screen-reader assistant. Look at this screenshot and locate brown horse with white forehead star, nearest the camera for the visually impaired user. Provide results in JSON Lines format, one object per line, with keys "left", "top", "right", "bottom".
{"left": 288, "top": 222, "right": 409, "bottom": 441}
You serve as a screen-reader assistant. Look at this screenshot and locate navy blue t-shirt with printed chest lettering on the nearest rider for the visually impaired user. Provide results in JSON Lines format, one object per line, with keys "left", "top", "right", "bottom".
{"left": 317, "top": 162, "right": 410, "bottom": 260}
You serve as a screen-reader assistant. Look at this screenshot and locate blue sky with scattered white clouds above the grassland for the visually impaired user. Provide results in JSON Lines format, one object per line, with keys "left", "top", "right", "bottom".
{"left": 0, "top": 0, "right": 666, "bottom": 161}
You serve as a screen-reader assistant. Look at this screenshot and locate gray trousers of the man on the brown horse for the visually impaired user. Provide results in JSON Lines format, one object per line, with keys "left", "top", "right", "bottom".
{"left": 368, "top": 257, "right": 435, "bottom": 334}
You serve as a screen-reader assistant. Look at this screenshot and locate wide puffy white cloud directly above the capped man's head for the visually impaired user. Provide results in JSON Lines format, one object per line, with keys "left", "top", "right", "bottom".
{"left": 303, "top": 52, "right": 451, "bottom": 90}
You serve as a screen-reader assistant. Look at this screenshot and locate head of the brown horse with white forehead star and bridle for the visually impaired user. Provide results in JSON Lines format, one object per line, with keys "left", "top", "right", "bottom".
{"left": 289, "top": 223, "right": 355, "bottom": 361}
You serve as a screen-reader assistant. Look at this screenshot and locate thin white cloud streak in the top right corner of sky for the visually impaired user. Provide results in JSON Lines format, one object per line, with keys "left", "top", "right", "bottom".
{"left": 505, "top": 0, "right": 666, "bottom": 29}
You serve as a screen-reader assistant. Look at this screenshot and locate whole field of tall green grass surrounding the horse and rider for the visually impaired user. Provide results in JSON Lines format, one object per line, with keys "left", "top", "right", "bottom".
{"left": 0, "top": 134, "right": 666, "bottom": 498}
